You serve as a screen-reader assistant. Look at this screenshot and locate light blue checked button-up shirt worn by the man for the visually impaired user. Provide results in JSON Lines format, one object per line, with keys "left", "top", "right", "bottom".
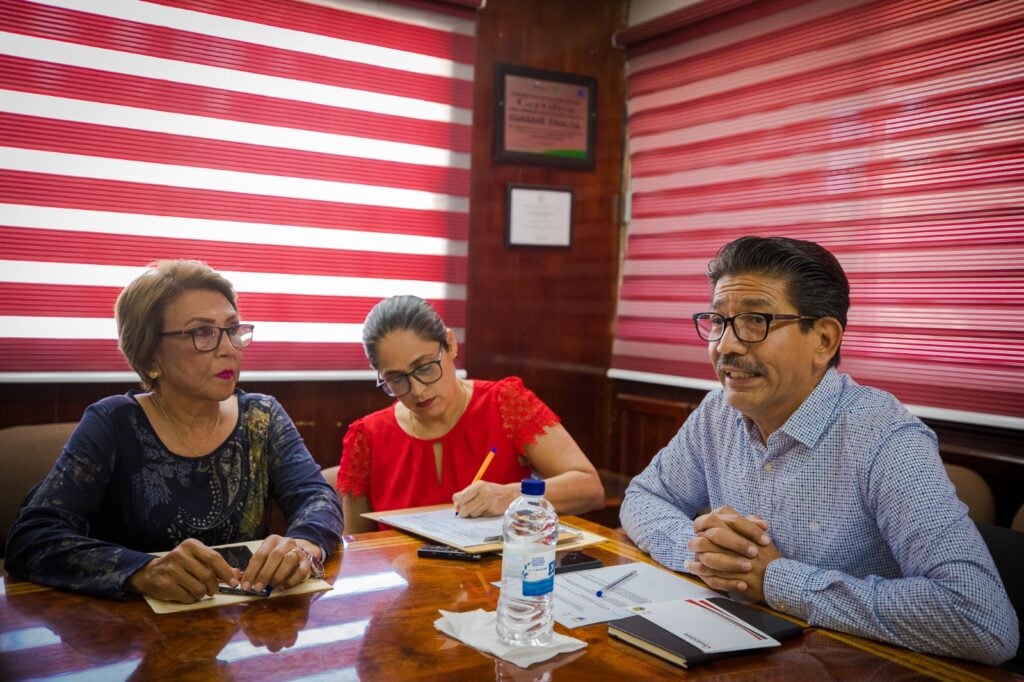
{"left": 622, "top": 370, "right": 1019, "bottom": 664}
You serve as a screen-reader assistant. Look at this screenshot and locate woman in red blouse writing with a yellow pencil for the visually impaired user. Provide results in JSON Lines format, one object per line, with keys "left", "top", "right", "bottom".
{"left": 338, "top": 296, "right": 604, "bottom": 534}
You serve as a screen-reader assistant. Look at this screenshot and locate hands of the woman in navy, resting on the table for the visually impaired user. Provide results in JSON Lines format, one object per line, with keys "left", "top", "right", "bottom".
{"left": 127, "top": 536, "right": 319, "bottom": 604}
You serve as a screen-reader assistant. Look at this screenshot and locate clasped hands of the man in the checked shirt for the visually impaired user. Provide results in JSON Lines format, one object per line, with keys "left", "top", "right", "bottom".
{"left": 685, "top": 506, "right": 782, "bottom": 601}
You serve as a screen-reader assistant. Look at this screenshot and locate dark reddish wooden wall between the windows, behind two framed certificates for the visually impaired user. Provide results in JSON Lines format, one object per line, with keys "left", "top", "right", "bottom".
{"left": 466, "top": 0, "right": 627, "bottom": 467}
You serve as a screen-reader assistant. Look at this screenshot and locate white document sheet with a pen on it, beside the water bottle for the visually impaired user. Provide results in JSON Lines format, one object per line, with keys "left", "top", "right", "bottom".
{"left": 554, "top": 563, "right": 720, "bottom": 628}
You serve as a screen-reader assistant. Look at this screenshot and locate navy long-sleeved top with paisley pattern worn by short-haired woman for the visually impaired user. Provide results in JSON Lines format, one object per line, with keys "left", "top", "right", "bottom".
{"left": 5, "top": 389, "right": 342, "bottom": 598}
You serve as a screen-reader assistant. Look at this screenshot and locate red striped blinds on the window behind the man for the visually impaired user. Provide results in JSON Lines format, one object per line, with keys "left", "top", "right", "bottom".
{"left": 611, "top": 0, "right": 1024, "bottom": 428}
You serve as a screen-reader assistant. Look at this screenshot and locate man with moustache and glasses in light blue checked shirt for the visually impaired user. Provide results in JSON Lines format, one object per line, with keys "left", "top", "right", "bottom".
{"left": 622, "top": 237, "right": 1019, "bottom": 665}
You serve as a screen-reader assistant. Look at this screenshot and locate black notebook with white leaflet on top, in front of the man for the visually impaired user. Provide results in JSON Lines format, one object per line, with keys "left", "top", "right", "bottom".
{"left": 608, "top": 597, "right": 804, "bottom": 668}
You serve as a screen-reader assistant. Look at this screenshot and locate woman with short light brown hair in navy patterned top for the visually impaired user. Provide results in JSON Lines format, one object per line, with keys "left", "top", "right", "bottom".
{"left": 5, "top": 260, "right": 342, "bottom": 603}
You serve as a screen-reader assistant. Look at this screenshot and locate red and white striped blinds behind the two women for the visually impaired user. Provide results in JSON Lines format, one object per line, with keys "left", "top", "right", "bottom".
{"left": 0, "top": 0, "right": 474, "bottom": 381}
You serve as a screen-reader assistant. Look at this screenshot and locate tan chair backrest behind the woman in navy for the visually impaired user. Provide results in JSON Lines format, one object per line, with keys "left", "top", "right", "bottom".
{"left": 0, "top": 422, "right": 78, "bottom": 556}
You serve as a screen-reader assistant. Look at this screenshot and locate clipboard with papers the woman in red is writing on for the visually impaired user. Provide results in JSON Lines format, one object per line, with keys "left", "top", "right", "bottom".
{"left": 360, "top": 505, "right": 605, "bottom": 554}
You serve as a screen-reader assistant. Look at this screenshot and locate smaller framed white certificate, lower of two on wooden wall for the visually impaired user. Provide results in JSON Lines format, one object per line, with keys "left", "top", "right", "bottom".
{"left": 505, "top": 184, "right": 572, "bottom": 248}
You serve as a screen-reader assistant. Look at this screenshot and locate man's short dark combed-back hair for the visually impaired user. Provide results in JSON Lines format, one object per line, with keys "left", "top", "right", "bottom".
{"left": 708, "top": 237, "right": 850, "bottom": 367}
